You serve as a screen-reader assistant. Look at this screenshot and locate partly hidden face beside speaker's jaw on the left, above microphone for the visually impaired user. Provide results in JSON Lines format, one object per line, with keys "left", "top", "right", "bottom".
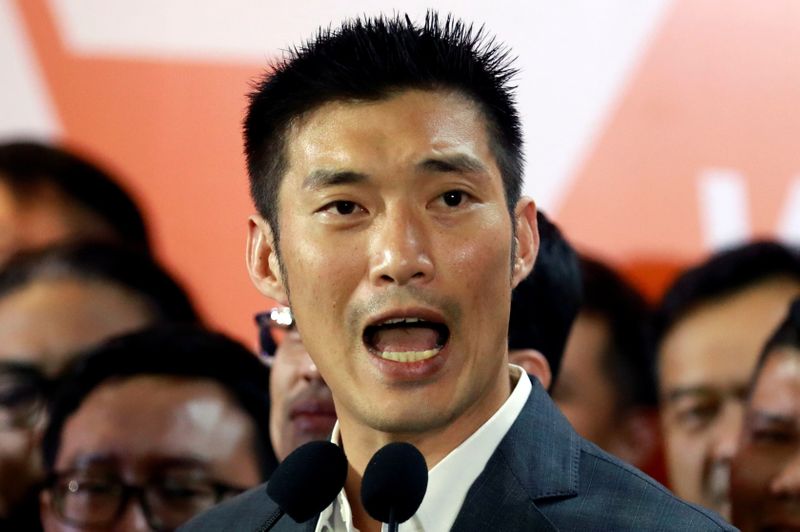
{"left": 269, "top": 330, "right": 336, "bottom": 460}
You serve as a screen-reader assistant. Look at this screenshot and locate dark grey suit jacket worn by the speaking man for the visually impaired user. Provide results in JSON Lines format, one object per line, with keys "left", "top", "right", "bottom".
{"left": 180, "top": 379, "right": 735, "bottom": 532}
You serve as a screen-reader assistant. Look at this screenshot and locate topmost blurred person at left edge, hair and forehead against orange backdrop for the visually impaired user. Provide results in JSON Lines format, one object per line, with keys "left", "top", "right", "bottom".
{"left": 0, "top": 141, "right": 149, "bottom": 264}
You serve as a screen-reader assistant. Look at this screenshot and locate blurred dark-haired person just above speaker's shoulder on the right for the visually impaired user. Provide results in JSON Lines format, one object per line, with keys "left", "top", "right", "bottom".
{"left": 552, "top": 257, "right": 659, "bottom": 468}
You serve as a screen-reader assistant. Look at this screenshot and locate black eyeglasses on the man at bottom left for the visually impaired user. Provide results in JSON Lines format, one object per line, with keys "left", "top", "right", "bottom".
{"left": 45, "top": 470, "right": 245, "bottom": 532}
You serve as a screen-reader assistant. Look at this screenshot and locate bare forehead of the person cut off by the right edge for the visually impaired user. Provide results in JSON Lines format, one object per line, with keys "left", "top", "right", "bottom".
{"left": 750, "top": 347, "right": 800, "bottom": 420}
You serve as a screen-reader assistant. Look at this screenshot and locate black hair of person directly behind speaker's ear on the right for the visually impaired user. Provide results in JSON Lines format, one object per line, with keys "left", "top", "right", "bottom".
{"left": 508, "top": 211, "right": 583, "bottom": 388}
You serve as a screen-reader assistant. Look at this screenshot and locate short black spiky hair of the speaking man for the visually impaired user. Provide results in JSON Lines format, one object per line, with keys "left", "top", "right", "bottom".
{"left": 244, "top": 12, "right": 523, "bottom": 241}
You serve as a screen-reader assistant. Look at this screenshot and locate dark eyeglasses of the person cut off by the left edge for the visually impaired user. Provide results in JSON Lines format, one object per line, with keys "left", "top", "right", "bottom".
{"left": 0, "top": 362, "right": 52, "bottom": 431}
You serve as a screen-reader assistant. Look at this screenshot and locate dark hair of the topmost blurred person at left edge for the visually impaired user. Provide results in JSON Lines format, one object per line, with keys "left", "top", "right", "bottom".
{"left": 0, "top": 141, "right": 150, "bottom": 251}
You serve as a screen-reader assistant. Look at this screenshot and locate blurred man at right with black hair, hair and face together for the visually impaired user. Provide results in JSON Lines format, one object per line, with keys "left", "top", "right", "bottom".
{"left": 657, "top": 242, "right": 800, "bottom": 517}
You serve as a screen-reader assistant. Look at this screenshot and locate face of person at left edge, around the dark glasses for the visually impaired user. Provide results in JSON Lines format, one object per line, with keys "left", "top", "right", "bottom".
{"left": 0, "top": 280, "right": 152, "bottom": 515}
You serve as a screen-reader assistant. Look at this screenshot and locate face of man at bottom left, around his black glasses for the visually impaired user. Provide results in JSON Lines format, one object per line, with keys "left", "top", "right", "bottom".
{"left": 42, "top": 376, "right": 261, "bottom": 532}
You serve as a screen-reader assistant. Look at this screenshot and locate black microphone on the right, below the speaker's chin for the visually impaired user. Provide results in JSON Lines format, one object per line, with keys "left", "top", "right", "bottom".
{"left": 361, "top": 442, "right": 428, "bottom": 532}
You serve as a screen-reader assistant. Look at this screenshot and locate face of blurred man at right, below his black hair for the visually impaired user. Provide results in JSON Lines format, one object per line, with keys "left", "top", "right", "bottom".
{"left": 659, "top": 279, "right": 800, "bottom": 516}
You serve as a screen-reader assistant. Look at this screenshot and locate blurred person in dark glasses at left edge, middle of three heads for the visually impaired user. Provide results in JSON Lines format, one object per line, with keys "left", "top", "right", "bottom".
{"left": 0, "top": 243, "right": 198, "bottom": 528}
